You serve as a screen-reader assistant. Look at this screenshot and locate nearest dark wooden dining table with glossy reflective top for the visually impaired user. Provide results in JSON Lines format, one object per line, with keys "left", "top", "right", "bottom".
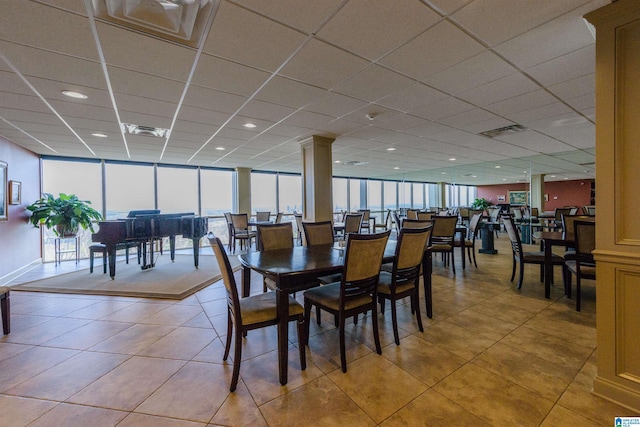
{"left": 238, "top": 240, "right": 433, "bottom": 385}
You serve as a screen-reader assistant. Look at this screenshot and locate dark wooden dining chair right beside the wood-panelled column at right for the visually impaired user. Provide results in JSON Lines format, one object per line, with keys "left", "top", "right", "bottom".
{"left": 565, "top": 221, "right": 596, "bottom": 311}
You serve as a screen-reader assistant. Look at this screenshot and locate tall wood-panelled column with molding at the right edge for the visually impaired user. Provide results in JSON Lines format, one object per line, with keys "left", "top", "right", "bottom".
{"left": 586, "top": 0, "right": 640, "bottom": 412}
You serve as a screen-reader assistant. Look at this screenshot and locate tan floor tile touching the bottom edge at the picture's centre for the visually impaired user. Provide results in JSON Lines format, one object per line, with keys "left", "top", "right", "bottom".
{"left": 260, "top": 377, "right": 376, "bottom": 427}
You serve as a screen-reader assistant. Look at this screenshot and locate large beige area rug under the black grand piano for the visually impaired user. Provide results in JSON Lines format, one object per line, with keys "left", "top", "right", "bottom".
{"left": 11, "top": 254, "right": 240, "bottom": 299}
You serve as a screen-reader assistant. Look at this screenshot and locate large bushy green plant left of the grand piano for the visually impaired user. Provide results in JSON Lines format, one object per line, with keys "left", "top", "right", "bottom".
{"left": 27, "top": 193, "right": 102, "bottom": 237}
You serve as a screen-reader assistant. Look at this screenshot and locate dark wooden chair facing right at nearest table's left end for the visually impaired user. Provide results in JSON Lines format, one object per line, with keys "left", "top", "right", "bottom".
{"left": 207, "top": 233, "right": 307, "bottom": 391}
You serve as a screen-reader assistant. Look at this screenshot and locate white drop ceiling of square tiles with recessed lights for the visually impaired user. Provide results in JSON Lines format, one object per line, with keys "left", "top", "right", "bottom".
{"left": 0, "top": 0, "right": 609, "bottom": 185}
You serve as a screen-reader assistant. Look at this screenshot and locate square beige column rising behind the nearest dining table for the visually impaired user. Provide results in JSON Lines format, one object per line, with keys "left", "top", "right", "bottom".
{"left": 300, "top": 135, "right": 335, "bottom": 221}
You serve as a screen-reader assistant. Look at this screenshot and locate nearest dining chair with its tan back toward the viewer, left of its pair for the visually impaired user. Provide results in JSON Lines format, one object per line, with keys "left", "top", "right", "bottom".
{"left": 304, "top": 231, "right": 391, "bottom": 372}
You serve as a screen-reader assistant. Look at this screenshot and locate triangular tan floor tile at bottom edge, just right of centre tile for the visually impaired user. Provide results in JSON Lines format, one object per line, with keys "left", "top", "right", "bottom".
{"left": 380, "top": 389, "right": 490, "bottom": 427}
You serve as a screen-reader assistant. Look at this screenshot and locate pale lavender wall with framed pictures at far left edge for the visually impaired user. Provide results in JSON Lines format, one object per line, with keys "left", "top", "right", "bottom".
{"left": 0, "top": 136, "right": 41, "bottom": 283}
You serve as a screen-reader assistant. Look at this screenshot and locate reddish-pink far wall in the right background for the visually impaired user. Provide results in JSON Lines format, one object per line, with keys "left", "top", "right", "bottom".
{"left": 478, "top": 179, "right": 593, "bottom": 211}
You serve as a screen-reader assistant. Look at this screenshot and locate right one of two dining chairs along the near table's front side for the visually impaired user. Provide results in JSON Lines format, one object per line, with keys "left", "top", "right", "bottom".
{"left": 378, "top": 229, "right": 431, "bottom": 345}
